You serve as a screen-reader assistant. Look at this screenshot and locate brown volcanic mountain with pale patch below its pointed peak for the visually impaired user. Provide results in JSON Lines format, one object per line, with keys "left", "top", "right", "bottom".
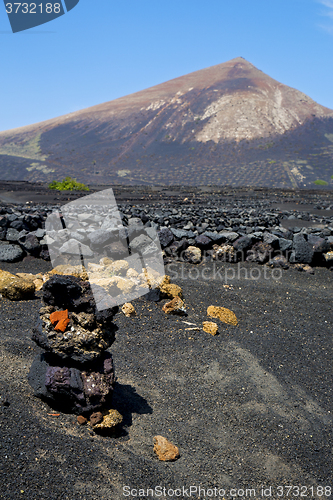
{"left": 0, "top": 57, "right": 333, "bottom": 188}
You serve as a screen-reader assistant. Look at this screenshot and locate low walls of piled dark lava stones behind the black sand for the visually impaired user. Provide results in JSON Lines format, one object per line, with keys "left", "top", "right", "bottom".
{"left": 0, "top": 200, "right": 333, "bottom": 268}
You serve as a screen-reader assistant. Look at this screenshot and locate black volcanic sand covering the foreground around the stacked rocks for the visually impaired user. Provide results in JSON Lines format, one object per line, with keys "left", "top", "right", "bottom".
{"left": 0, "top": 259, "right": 333, "bottom": 500}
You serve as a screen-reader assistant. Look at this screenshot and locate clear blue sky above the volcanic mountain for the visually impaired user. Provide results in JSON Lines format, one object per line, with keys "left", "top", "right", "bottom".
{"left": 0, "top": 0, "right": 333, "bottom": 131}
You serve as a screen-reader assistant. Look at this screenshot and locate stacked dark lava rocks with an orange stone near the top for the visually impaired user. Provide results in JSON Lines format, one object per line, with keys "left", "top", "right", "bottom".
{"left": 28, "top": 275, "right": 118, "bottom": 414}
